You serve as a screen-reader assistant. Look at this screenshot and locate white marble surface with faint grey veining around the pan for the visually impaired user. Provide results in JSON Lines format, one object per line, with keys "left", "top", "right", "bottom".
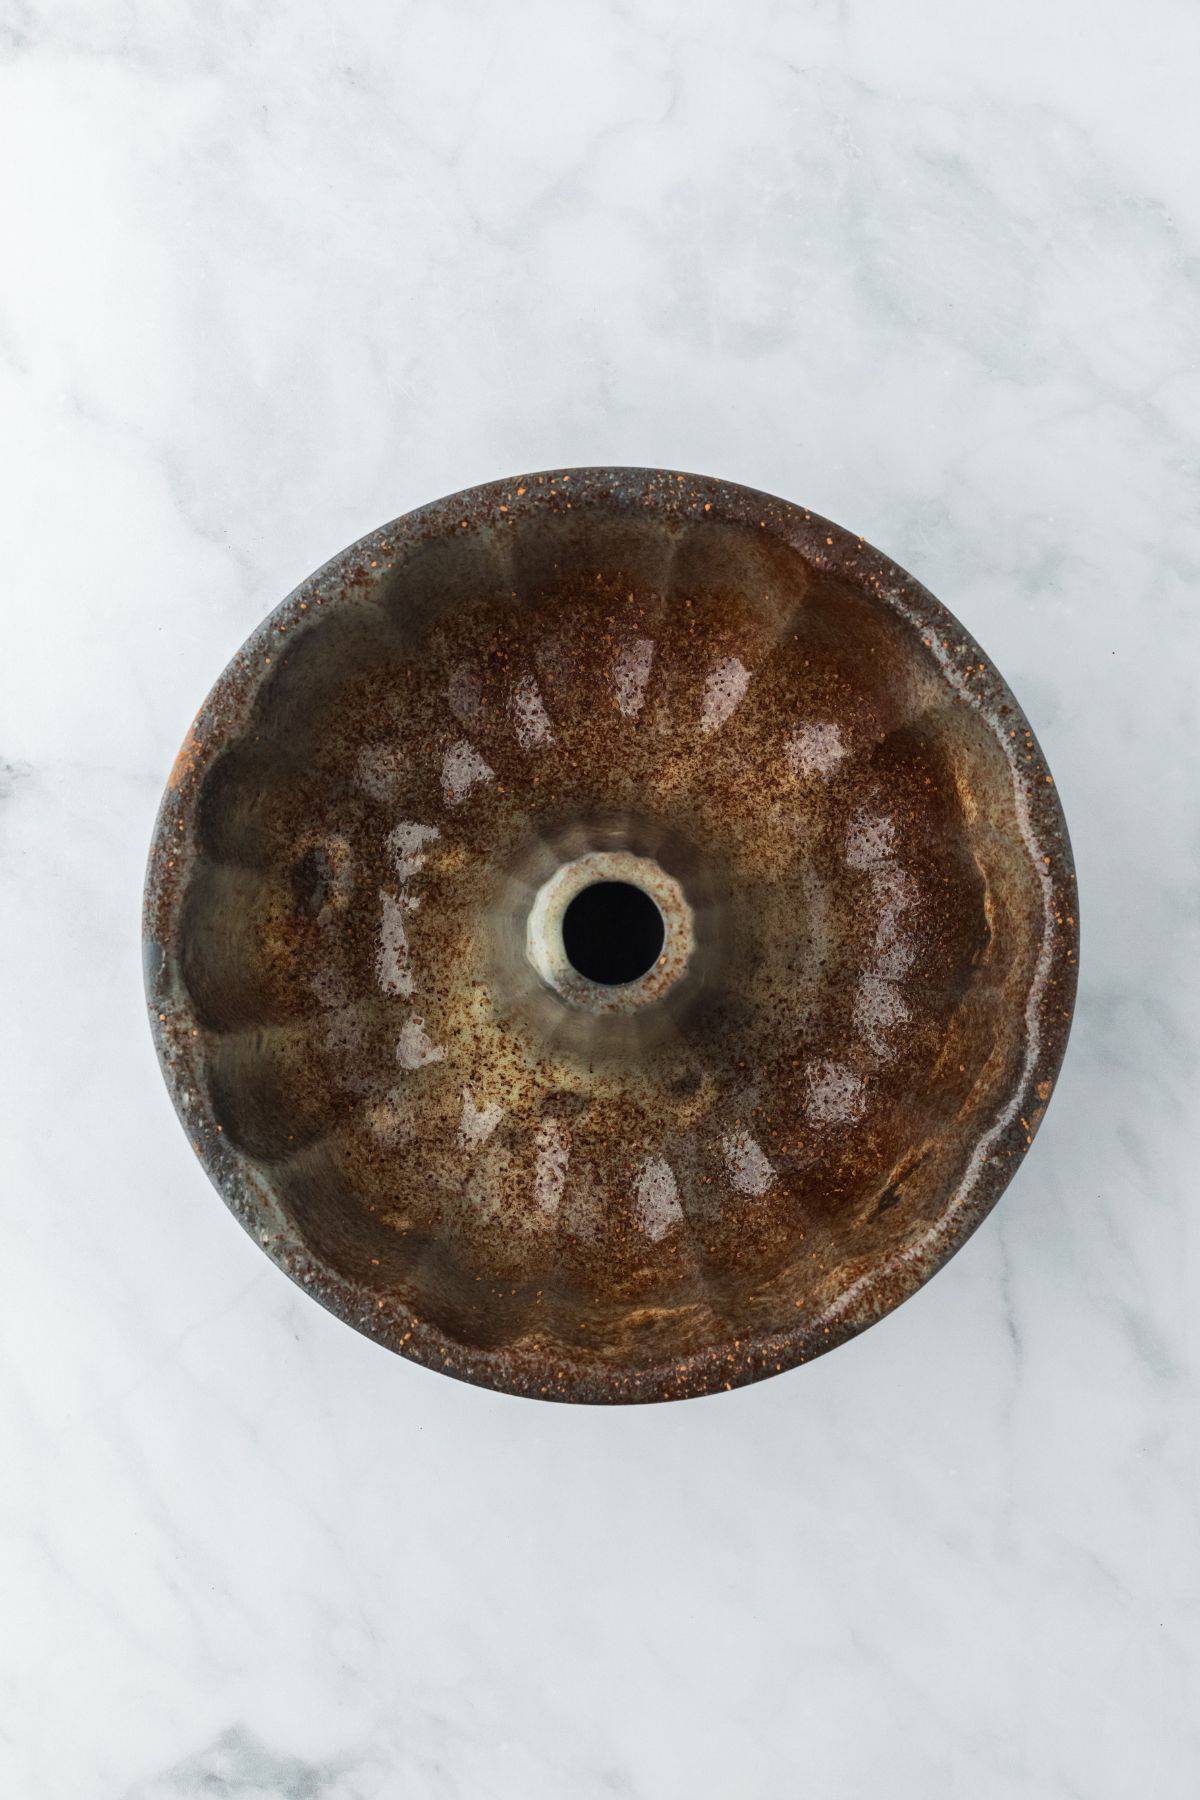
{"left": 0, "top": 0, "right": 1200, "bottom": 1800}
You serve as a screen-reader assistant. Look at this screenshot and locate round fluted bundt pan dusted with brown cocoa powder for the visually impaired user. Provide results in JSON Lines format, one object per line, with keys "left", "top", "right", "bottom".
{"left": 146, "top": 468, "right": 1078, "bottom": 1400}
